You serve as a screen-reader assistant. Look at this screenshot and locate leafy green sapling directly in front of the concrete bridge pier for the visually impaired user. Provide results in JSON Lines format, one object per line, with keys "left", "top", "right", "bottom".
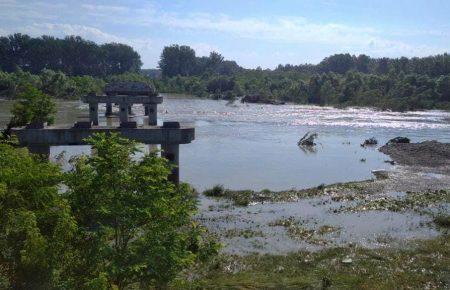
{"left": 65, "top": 134, "right": 203, "bottom": 289}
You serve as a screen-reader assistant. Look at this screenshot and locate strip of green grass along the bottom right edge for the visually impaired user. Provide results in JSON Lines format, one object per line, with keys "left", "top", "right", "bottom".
{"left": 173, "top": 235, "right": 450, "bottom": 289}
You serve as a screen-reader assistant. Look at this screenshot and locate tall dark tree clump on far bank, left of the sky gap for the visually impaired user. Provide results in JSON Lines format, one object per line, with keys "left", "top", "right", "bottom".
{"left": 0, "top": 33, "right": 142, "bottom": 76}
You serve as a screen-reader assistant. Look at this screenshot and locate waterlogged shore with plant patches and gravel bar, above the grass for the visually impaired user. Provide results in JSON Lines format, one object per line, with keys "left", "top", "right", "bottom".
{"left": 198, "top": 142, "right": 450, "bottom": 255}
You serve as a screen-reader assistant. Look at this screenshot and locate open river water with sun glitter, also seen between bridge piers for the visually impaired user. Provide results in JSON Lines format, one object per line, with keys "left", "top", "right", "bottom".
{"left": 0, "top": 95, "right": 450, "bottom": 190}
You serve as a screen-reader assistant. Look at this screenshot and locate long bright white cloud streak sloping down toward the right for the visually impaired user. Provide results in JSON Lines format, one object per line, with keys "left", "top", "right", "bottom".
{"left": 151, "top": 14, "right": 448, "bottom": 56}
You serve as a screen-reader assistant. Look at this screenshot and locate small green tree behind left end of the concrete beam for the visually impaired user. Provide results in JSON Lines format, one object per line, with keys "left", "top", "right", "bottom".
{"left": 11, "top": 85, "right": 56, "bottom": 126}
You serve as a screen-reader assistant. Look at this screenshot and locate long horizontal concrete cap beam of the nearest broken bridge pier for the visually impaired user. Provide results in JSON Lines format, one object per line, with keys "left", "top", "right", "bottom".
{"left": 11, "top": 126, "right": 195, "bottom": 146}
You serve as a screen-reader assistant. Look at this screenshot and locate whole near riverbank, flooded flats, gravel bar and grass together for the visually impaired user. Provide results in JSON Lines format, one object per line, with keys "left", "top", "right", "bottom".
{"left": 178, "top": 142, "right": 450, "bottom": 289}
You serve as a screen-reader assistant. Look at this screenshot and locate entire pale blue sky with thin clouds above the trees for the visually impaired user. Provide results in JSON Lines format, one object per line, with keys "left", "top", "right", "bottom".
{"left": 0, "top": 0, "right": 450, "bottom": 68}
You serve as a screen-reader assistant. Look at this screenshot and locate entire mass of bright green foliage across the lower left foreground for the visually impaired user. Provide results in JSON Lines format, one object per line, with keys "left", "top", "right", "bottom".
{"left": 0, "top": 135, "right": 217, "bottom": 289}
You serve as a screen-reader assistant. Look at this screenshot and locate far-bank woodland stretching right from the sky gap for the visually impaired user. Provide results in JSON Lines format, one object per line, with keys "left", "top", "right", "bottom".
{"left": 155, "top": 46, "right": 450, "bottom": 111}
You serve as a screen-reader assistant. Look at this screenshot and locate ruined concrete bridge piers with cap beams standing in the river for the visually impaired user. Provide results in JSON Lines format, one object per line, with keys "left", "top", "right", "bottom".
{"left": 11, "top": 82, "right": 195, "bottom": 183}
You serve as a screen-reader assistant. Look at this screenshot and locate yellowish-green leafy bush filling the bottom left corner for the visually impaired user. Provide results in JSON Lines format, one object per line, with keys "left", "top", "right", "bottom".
{"left": 0, "top": 144, "right": 77, "bottom": 289}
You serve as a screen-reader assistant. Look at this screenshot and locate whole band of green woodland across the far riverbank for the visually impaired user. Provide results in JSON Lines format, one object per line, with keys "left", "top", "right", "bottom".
{"left": 0, "top": 34, "right": 450, "bottom": 111}
